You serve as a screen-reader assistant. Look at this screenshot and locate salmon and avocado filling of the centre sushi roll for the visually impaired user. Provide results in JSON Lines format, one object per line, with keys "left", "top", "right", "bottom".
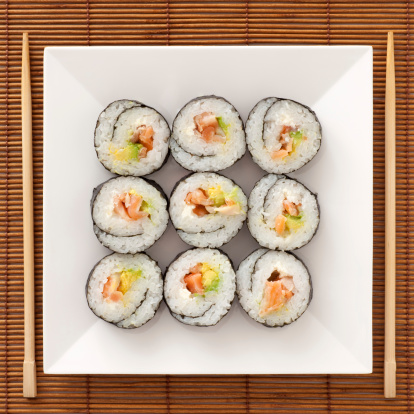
{"left": 184, "top": 186, "right": 242, "bottom": 217}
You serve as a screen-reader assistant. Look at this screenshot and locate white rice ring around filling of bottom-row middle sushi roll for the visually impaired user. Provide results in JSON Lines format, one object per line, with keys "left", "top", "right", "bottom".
{"left": 164, "top": 249, "right": 236, "bottom": 326}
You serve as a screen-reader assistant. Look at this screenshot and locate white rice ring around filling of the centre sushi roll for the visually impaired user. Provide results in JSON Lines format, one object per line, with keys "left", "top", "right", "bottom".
{"left": 170, "top": 173, "right": 247, "bottom": 247}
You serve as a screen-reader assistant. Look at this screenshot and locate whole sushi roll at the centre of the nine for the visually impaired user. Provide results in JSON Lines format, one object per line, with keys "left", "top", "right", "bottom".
{"left": 170, "top": 173, "right": 247, "bottom": 247}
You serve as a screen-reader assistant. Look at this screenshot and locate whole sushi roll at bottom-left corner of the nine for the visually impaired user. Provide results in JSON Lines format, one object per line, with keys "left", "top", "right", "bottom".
{"left": 86, "top": 253, "right": 163, "bottom": 328}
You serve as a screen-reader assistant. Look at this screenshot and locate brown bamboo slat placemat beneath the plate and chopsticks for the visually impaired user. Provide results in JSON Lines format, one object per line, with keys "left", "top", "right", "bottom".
{"left": 0, "top": 0, "right": 414, "bottom": 414}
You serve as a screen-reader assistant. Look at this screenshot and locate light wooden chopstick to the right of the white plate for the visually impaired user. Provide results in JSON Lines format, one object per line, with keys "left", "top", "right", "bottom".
{"left": 384, "top": 32, "right": 396, "bottom": 398}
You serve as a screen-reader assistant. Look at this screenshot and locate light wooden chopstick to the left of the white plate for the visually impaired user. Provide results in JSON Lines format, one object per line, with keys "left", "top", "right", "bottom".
{"left": 21, "top": 33, "right": 37, "bottom": 398}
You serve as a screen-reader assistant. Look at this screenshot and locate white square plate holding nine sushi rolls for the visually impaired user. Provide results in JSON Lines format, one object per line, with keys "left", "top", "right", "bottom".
{"left": 43, "top": 46, "right": 373, "bottom": 374}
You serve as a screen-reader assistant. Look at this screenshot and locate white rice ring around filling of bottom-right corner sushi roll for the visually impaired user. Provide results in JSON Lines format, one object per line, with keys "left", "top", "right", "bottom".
{"left": 237, "top": 249, "right": 312, "bottom": 326}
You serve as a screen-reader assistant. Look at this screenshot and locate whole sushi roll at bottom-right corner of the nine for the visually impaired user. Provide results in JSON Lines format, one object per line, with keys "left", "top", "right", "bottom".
{"left": 237, "top": 249, "right": 312, "bottom": 327}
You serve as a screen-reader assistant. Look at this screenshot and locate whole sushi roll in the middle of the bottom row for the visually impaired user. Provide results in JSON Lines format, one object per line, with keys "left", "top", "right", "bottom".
{"left": 164, "top": 249, "right": 236, "bottom": 326}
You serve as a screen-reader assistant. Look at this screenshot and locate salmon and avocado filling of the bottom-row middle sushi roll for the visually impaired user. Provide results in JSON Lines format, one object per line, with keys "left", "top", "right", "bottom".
{"left": 184, "top": 263, "right": 220, "bottom": 295}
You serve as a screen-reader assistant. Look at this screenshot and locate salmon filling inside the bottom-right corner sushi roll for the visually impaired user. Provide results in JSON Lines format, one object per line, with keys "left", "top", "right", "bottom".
{"left": 259, "top": 270, "right": 295, "bottom": 316}
